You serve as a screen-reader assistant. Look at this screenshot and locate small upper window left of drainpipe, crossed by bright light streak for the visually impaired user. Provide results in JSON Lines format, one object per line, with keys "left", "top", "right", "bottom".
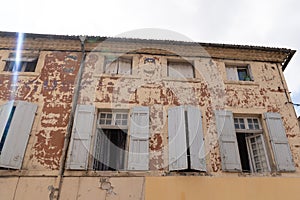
{"left": 4, "top": 53, "right": 38, "bottom": 72}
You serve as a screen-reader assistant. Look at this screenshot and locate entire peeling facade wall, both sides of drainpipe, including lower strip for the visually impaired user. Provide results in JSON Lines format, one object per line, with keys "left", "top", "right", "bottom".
{"left": 0, "top": 34, "right": 300, "bottom": 199}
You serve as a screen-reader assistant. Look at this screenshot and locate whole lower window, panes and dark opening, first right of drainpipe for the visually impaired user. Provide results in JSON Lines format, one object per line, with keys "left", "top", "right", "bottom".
{"left": 93, "top": 111, "right": 128, "bottom": 171}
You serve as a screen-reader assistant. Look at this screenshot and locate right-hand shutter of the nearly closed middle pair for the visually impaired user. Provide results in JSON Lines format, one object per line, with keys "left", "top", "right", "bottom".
{"left": 187, "top": 106, "right": 206, "bottom": 171}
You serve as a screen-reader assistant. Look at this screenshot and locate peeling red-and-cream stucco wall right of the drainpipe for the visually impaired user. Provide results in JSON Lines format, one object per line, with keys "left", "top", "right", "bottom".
{"left": 79, "top": 52, "right": 300, "bottom": 175}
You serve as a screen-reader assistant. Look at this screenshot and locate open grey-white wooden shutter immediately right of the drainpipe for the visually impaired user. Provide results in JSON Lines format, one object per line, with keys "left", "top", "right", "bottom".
{"left": 67, "top": 105, "right": 95, "bottom": 170}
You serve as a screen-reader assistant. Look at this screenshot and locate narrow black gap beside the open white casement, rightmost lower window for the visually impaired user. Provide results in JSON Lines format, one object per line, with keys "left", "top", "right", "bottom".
{"left": 236, "top": 133, "right": 251, "bottom": 172}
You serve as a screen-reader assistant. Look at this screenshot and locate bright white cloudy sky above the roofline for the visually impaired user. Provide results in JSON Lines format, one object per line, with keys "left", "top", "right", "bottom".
{"left": 0, "top": 0, "right": 300, "bottom": 116}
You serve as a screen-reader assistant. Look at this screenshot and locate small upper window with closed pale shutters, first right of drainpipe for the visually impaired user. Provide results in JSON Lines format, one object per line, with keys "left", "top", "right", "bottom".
{"left": 104, "top": 56, "right": 132, "bottom": 74}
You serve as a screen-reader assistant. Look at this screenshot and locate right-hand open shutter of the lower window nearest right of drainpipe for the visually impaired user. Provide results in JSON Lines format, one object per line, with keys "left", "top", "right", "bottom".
{"left": 128, "top": 106, "right": 149, "bottom": 170}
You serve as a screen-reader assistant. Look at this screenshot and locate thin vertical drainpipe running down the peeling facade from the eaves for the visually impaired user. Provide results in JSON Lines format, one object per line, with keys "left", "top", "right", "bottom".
{"left": 56, "top": 36, "right": 86, "bottom": 199}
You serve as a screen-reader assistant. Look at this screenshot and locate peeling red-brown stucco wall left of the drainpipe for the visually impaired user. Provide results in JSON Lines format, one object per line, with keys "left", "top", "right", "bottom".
{"left": 0, "top": 50, "right": 81, "bottom": 173}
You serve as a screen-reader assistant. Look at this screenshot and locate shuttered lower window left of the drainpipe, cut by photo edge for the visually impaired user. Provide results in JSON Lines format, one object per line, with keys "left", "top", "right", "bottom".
{"left": 0, "top": 101, "right": 37, "bottom": 169}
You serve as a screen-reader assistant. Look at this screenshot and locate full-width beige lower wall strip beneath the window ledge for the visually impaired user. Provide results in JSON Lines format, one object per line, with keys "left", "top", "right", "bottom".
{"left": 0, "top": 176, "right": 300, "bottom": 200}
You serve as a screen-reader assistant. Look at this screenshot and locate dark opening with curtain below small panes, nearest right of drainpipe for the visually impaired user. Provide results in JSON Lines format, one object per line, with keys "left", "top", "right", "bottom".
{"left": 93, "top": 129, "right": 127, "bottom": 171}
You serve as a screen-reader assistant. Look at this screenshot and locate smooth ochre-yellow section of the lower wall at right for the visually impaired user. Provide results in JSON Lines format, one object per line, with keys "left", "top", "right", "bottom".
{"left": 145, "top": 177, "right": 300, "bottom": 200}
